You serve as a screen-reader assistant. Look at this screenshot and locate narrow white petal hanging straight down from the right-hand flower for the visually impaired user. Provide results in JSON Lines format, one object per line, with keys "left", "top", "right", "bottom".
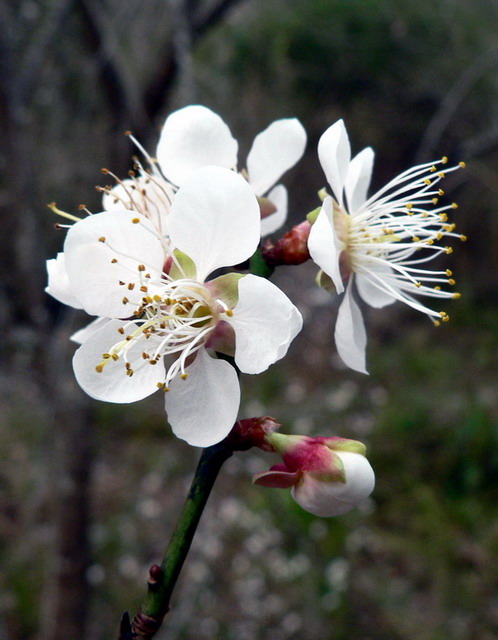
{"left": 335, "top": 278, "right": 368, "bottom": 373}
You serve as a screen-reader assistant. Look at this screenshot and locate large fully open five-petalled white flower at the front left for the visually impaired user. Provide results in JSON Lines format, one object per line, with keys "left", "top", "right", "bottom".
{"left": 57, "top": 167, "right": 302, "bottom": 446}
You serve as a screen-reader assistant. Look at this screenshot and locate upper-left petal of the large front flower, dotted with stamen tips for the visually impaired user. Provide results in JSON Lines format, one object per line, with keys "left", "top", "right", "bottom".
{"left": 64, "top": 211, "right": 165, "bottom": 318}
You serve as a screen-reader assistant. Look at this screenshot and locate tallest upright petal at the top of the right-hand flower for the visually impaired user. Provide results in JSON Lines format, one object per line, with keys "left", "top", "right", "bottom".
{"left": 318, "top": 120, "right": 351, "bottom": 206}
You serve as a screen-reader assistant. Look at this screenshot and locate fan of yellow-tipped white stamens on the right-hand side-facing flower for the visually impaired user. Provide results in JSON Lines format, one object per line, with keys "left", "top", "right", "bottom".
{"left": 335, "top": 157, "right": 466, "bottom": 325}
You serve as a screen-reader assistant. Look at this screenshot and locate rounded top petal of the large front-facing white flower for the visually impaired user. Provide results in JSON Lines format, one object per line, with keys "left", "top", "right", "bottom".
{"left": 168, "top": 167, "right": 261, "bottom": 281}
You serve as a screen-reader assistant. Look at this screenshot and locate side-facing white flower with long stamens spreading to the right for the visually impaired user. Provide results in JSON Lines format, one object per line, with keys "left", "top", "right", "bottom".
{"left": 308, "top": 120, "right": 465, "bottom": 373}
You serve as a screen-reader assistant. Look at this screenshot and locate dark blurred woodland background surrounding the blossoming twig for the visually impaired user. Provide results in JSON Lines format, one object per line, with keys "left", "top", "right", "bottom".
{"left": 0, "top": 0, "right": 498, "bottom": 640}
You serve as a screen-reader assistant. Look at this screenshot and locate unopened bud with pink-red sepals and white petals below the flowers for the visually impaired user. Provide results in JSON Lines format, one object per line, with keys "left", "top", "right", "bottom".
{"left": 253, "top": 433, "right": 375, "bottom": 517}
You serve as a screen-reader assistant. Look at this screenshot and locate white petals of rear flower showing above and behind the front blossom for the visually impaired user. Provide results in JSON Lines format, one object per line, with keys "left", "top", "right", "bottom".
{"left": 157, "top": 105, "right": 306, "bottom": 235}
